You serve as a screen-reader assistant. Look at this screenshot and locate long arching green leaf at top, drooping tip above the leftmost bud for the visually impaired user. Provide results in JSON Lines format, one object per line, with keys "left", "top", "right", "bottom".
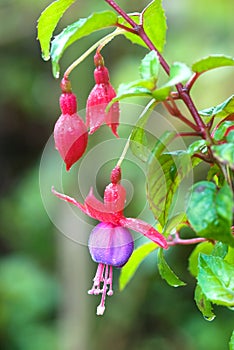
{"left": 51, "top": 11, "right": 117, "bottom": 77}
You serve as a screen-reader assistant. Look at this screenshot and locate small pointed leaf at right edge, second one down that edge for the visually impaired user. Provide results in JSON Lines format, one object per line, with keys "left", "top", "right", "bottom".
{"left": 199, "top": 95, "right": 234, "bottom": 119}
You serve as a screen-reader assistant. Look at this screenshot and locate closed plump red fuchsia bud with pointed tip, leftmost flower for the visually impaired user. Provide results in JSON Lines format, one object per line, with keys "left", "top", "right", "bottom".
{"left": 54, "top": 78, "right": 88, "bottom": 171}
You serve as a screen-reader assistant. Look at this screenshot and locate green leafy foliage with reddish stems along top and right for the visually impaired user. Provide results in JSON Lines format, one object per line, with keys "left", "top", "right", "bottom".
{"left": 38, "top": 0, "right": 234, "bottom": 346}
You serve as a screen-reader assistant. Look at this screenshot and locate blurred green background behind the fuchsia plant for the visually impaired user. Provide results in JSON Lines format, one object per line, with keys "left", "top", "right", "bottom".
{"left": 0, "top": 0, "right": 234, "bottom": 350}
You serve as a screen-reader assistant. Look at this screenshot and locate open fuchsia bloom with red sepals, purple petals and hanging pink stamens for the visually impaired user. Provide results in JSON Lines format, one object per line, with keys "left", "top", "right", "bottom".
{"left": 52, "top": 166, "right": 167, "bottom": 315}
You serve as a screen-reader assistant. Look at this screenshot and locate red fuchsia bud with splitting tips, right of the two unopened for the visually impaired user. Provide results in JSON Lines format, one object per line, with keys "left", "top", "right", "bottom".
{"left": 86, "top": 52, "right": 119, "bottom": 137}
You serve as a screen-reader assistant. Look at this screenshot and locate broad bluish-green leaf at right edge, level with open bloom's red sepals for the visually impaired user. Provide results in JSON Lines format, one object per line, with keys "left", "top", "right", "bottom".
{"left": 186, "top": 181, "right": 234, "bottom": 246}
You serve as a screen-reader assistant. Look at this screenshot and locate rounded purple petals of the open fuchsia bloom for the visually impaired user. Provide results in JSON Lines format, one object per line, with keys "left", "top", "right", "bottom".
{"left": 88, "top": 222, "right": 134, "bottom": 267}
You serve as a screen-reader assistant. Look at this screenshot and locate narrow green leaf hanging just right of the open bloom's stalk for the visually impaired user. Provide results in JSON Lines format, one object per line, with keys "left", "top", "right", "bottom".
{"left": 130, "top": 100, "right": 156, "bottom": 162}
